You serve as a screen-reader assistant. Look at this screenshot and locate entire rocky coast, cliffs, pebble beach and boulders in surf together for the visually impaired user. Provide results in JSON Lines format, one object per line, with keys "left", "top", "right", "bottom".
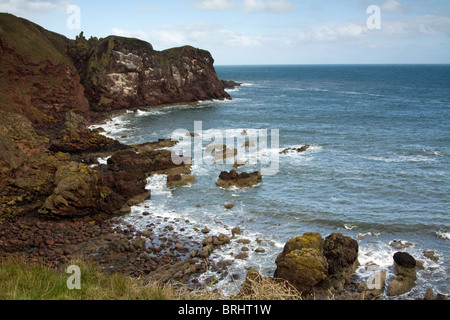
{"left": 0, "top": 13, "right": 445, "bottom": 299}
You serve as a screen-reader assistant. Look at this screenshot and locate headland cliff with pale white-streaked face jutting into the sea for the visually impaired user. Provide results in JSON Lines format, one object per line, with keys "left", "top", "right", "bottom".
{"left": 69, "top": 35, "right": 230, "bottom": 111}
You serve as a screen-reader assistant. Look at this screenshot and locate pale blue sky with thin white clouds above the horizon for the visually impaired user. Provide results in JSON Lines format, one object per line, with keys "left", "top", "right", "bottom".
{"left": 0, "top": 0, "right": 450, "bottom": 65}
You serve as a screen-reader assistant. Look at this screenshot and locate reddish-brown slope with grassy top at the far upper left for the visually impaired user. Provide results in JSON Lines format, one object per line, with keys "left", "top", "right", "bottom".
{"left": 0, "top": 13, "right": 90, "bottom": 137}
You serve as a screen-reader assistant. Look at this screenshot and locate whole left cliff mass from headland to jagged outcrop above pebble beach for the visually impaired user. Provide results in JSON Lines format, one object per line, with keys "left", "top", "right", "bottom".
{"left": 0, "top": 13, "right": 230, "bottom": 223}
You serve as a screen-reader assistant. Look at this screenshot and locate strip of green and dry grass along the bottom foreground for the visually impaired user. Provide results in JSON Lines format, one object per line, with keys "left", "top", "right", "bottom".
{"left": 0, "top": 258, "right": 301, "bottom": 301}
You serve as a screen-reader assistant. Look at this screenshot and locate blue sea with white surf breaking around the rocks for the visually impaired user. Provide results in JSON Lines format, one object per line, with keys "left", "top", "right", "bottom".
{"left": 89, "top": 65, "right": 450, "bottom": 299}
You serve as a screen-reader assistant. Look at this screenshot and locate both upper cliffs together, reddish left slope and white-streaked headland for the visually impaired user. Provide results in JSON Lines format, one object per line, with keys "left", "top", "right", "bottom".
{"left": 0, "top": 13, "right": 230, "bottom": 138}
